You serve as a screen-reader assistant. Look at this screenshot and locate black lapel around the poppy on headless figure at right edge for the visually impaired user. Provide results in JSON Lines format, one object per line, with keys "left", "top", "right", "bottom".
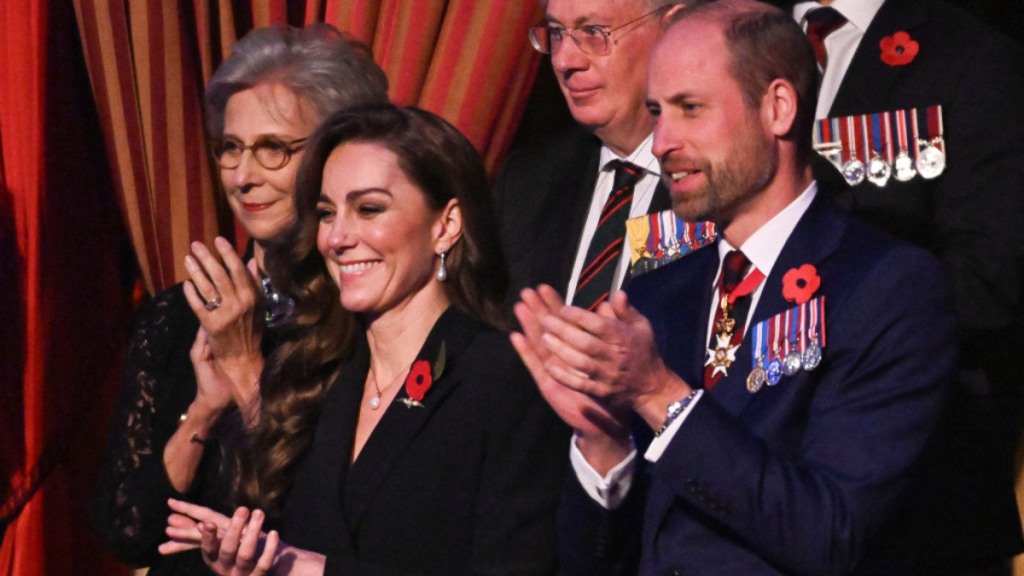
{"left": 828, "top": 0, "right": 928, "bottom": 118}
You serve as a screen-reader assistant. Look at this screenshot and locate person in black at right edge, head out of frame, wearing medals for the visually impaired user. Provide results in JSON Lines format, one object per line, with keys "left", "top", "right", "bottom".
{"left": 785, "top": 0, "right": 1024, "bottom": 576}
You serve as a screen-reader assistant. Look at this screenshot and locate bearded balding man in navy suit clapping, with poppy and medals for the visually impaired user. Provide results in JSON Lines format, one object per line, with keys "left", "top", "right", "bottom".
{"left": 512, "top": 0, "right": 956, "bottom": 576}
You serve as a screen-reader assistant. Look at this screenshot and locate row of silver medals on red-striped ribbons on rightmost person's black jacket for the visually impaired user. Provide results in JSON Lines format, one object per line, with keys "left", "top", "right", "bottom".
{"left": 814, "top": 106, "right": 946, "bottom": 183}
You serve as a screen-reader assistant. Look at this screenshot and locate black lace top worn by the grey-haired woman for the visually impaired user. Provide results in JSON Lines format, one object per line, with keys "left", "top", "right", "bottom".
{"left": 92, "top": 284, "right": 232, "bottom": 576}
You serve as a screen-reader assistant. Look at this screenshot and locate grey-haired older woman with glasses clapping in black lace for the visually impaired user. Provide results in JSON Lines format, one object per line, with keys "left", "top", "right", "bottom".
{"left": 93, "top": 25, "right": 387, "bottom": 576}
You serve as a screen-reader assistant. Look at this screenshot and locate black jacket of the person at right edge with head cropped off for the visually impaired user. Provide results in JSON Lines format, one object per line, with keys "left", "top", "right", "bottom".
{"left": 794, "top": 0, "right": 1024, "bottom": 561}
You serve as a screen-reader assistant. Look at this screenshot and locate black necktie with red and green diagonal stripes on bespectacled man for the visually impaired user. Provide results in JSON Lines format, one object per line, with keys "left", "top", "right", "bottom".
{"left": 572, "top": 160, "right": 644, "bottom": 311}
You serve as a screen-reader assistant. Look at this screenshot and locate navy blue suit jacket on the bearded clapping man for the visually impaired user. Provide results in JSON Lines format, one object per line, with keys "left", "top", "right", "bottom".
{"left": 560, "top": 195, "right": 956, "bottom": 576}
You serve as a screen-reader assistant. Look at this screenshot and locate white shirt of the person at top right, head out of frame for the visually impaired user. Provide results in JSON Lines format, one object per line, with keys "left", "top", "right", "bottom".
{"left": 793, "top": 0, "right": 885, "bottom": 119}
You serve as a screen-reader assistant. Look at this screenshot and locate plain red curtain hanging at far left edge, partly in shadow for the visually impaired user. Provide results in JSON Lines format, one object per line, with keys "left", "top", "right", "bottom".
{"left": 0, "top": 0, "right": 130, "bottom": 575}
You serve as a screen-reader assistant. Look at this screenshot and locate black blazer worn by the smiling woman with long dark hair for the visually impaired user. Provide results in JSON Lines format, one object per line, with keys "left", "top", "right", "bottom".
{"left": 282, "top": 308, "right": 569, "bottom": 575}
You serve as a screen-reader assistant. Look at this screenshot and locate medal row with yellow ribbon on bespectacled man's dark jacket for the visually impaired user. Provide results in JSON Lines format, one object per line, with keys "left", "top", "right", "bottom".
{"left": 626, "top": 210, "right": 718, "bottom": 278}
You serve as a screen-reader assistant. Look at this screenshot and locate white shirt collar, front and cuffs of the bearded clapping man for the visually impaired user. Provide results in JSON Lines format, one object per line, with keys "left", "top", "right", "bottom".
{"left": 569, "top": 182, "right": 818, "bottom": 509}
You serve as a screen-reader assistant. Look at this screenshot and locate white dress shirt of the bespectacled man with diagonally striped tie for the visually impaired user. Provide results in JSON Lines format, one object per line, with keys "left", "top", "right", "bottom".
{"left": 565, "top": 135, "right": 662, "bottom": 304}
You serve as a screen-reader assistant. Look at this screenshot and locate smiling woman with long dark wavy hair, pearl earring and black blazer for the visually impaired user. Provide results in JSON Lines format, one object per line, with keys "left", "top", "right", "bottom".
{"left": 166, "top": 106, "right": 568, "bottom": 575}
